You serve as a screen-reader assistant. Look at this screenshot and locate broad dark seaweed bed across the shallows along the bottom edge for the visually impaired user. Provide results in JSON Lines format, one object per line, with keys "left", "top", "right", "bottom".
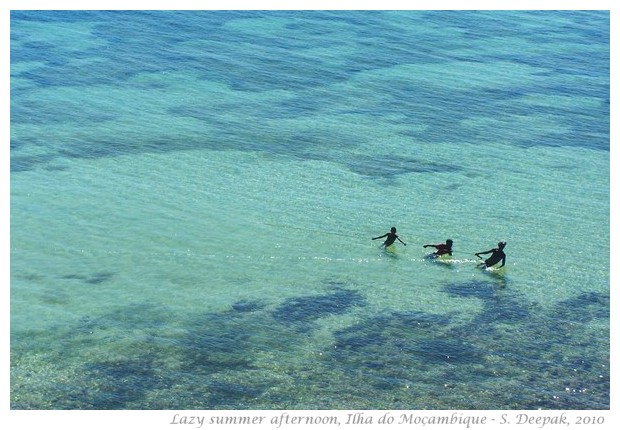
{"left": 12, "top": 275, "right": 609, "bottom": 409}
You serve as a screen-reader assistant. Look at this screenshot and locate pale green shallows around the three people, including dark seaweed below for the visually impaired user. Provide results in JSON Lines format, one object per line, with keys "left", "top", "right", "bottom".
{"left": 11, "top": 142, "right": 609, "bottom": 408}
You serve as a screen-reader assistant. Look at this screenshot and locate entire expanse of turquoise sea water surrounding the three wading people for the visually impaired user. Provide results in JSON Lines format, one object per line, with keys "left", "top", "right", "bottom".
{"left": 10, "top": 11, "right": 610, "bottom": 409}
